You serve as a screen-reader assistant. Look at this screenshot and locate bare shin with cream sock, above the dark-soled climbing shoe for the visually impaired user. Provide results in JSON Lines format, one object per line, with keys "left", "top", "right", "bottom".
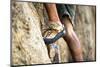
{"left": 44, "top": 4, "right": 63, "bottom": 31}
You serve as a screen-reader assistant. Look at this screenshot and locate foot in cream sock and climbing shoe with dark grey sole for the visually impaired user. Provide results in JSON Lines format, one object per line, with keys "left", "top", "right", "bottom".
{"left": 43, "top": 22, "right": 65, "bottom": 44}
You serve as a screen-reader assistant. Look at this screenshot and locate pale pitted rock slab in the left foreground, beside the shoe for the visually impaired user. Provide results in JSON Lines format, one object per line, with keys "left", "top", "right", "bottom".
{"left": 12, "top": 2, "right": 51, "bottom": 65}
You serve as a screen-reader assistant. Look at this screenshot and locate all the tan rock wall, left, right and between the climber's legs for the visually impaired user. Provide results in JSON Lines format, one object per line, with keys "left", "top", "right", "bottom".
{"left": 12, "top": 2, "right": 96, "bottom": 65}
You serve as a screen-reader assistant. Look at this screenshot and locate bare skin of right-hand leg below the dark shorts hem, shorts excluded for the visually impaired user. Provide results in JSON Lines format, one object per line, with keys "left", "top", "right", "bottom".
{"left": 62, "top": 16, "right": 83, "bottom": 61}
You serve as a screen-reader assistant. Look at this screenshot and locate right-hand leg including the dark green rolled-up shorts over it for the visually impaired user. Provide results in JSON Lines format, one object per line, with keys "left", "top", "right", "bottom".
{"left": 57, "top": 4, "right": 83, "bottom": 61}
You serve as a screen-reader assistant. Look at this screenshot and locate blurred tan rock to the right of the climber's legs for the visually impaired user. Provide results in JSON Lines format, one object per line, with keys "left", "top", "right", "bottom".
{"left": 74, "top": 6, "right": 96, "bottom": 61}
